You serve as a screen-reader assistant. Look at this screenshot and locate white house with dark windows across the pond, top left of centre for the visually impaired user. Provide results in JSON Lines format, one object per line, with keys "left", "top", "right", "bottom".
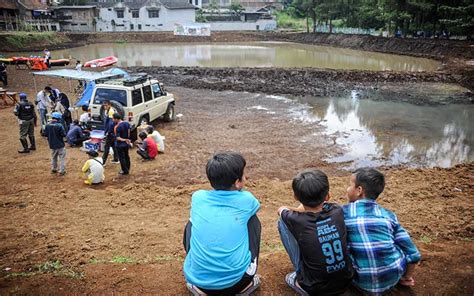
{"left": 91, "top": 0, "right": 196, "bottom": 32}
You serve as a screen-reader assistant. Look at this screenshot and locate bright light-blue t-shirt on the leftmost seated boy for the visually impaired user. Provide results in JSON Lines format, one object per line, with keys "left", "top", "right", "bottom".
{"left": 184, "top": 190, "right": 260, "bottom": 290}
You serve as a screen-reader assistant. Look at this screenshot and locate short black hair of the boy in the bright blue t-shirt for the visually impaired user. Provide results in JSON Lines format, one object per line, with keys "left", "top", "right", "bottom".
{"left": 206, "top": 152, "right": 247, "bottom": 190}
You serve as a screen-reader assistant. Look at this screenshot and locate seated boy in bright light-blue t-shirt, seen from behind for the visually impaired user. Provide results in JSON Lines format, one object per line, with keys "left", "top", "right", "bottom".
{"left": 183, "top": 152, "right": 261, "bottom": 295}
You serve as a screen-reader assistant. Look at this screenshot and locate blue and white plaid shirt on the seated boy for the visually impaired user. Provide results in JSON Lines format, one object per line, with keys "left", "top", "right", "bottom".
{"left": 343, "top": 199, "right": 421, "bottom": 294}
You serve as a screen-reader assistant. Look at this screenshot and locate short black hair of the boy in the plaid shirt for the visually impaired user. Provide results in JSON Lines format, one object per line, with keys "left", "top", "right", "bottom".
{"left": 353, "top": 168, "right": 385, "bottom": 200}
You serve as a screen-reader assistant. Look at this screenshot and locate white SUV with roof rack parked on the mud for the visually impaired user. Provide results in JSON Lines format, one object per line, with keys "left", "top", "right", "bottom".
{"left": 89, "top": 75, "right": 175, "bottom": 138}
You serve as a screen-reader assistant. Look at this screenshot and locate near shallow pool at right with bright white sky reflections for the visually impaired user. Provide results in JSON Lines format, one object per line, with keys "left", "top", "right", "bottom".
{"left": 290, "top": 96, "right": 474, "bottom": 168}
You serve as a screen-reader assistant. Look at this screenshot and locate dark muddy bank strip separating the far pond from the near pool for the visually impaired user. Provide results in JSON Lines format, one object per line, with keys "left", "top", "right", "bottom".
{"left": 129, "top": 67, "right": 474, "bottom": 105}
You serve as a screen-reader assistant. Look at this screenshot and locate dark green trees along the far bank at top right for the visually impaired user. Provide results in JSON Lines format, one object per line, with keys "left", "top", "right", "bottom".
{"left": 277, "top": 0, "right": 474, "bottom": 38}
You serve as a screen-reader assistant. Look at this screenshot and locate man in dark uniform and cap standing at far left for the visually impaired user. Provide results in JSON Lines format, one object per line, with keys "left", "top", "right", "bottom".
{"left": 13, "top": 93, "right": 37, "bottom": 153}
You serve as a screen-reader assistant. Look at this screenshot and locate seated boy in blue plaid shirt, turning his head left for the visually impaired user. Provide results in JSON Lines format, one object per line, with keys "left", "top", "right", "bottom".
{"left": 343, "top": 168, "right": 421, "bottom": 294}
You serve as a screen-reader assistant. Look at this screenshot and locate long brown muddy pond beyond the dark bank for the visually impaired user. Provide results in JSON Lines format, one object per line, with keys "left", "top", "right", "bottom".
{"left": 44, "top": 42, "right": 441, "bottom": 71}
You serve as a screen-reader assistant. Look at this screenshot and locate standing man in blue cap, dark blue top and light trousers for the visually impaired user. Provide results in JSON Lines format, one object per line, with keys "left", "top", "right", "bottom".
{"left": 44, "top": 112, "right": 66, "bottom": 176}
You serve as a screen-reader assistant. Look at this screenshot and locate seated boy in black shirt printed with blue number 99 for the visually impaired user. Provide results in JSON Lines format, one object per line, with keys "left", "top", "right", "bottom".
{"left": 278, "top": 170, "right": 354, "bottom": 295}
